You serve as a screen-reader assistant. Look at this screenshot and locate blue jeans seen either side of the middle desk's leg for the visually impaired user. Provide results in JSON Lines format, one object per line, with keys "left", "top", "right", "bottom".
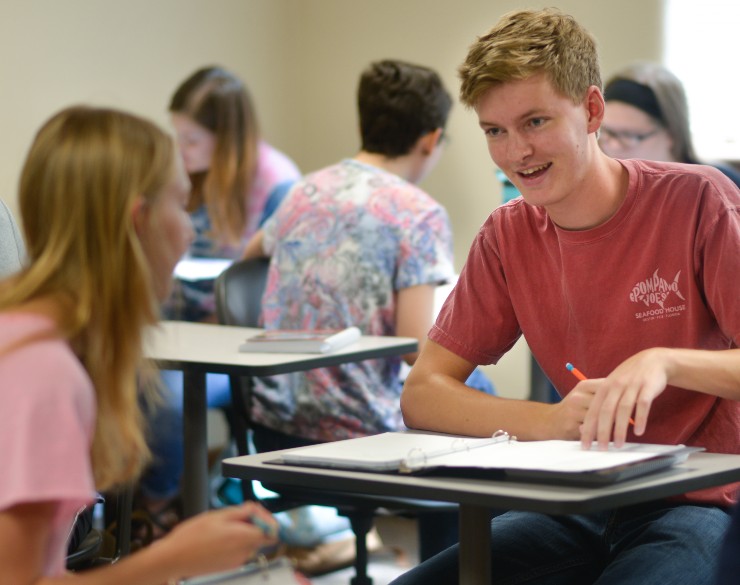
{"left": 140, "top": 370, "right": 231, "bottom": 499}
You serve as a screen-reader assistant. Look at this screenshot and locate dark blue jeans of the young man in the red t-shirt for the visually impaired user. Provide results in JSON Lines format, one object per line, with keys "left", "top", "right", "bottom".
{"left": 392, "top": 502, "right": 730, "bottom": 585}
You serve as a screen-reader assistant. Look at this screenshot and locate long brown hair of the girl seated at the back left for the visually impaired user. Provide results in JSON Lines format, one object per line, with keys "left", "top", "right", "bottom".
{"left": 169, "top": 67, "right": 259, "bottom": 244}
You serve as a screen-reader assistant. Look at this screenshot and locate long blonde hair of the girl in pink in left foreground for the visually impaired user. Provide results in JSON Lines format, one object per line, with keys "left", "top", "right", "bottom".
{"left": 0, "top": 107, "right": 175, "bottom": 489}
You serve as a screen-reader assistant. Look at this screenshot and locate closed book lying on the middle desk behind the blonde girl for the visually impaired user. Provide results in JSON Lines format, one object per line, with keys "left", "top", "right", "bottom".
{"left": 239, "top": 327, "right": 362, "bottom": 353}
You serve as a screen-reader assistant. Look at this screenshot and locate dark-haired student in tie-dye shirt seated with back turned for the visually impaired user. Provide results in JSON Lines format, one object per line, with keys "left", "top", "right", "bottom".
{"left": 247, "top": 60, "right": 492, "bottom": 557}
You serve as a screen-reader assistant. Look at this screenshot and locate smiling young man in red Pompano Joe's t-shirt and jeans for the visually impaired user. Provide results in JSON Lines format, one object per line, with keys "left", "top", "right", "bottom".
{"left": 397, "top": 9, "right": 740, "bottom": 585}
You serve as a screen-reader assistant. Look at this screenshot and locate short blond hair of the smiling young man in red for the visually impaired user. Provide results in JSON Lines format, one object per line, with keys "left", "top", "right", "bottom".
{"left": 458, "top": 8, "right": 601, "bottom": 107}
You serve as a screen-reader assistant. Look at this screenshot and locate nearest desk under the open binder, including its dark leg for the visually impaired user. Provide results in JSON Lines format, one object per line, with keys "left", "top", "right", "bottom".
{"left": 222, "top": 444, "right": 740, "bottom": 585}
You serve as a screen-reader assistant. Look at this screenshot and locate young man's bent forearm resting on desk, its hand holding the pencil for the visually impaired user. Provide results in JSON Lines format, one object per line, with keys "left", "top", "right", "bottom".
{"left": 401, "top": 340, "right": 592, "bottom": 441}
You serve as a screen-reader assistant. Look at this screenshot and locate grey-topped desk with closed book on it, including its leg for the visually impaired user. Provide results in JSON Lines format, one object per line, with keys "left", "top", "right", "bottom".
{"left": 144, "top": 321, "right": 417, "bottom": 516}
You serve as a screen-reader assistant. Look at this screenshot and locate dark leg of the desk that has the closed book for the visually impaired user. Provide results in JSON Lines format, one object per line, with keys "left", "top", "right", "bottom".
{"left": 182, "top": 371, "right": 208, "bottom": 518}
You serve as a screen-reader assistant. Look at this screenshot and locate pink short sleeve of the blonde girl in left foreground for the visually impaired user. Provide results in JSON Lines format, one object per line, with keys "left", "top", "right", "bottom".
{"left": 0, "top": 341, "right": 95, "bottom": 509}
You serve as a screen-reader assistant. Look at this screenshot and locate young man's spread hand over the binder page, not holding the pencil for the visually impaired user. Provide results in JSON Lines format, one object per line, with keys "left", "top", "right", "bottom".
{"left": 579, "top": 348, "right": 668, "bottom": 449}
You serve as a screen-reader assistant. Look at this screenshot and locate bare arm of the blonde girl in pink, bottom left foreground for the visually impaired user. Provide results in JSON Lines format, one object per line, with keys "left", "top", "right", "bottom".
{"left": 0, "top": 502, "right": 277, "bottom": 585}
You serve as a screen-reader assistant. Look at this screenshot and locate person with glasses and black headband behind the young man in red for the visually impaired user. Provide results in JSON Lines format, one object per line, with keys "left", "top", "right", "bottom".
{"left": 599, "top": 62, "right": 740, "bottom": 186}
